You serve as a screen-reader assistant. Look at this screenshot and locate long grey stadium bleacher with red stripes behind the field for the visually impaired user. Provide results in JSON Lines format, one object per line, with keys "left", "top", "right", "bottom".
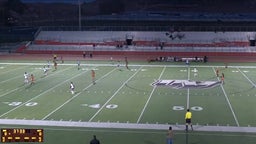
{"left": 17, "top": 31, "right": 256, "bottom": 62}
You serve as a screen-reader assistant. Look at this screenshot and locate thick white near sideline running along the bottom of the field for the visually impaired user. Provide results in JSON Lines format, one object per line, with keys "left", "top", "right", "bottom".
{"left": 0, "top": 119, "right": 256, "bottom": 133}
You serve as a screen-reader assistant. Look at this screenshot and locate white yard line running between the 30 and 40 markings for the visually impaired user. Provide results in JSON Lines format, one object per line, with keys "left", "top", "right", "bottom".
{"left": 42, "top": 69, "right": 116, "bottom": 120}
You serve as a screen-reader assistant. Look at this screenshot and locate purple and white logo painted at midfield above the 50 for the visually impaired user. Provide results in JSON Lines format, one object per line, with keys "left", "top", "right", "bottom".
{"left": 151, "top": 80, "right": 221, "bottom": 89}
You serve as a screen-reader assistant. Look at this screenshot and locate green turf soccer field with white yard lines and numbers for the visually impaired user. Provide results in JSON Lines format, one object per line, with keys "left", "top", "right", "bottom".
{"left": 0, "top": 61, "right": 256, "bottom": 143}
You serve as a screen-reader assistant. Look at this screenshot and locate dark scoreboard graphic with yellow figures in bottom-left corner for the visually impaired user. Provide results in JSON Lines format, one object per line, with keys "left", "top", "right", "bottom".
{"left": 1, "top": 128, "right": 44, "bottom": 143}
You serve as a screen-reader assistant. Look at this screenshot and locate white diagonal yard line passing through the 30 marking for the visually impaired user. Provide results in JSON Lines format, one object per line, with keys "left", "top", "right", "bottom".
{"left": 0, "top": 67, "right": 80, "bottom": 117}
